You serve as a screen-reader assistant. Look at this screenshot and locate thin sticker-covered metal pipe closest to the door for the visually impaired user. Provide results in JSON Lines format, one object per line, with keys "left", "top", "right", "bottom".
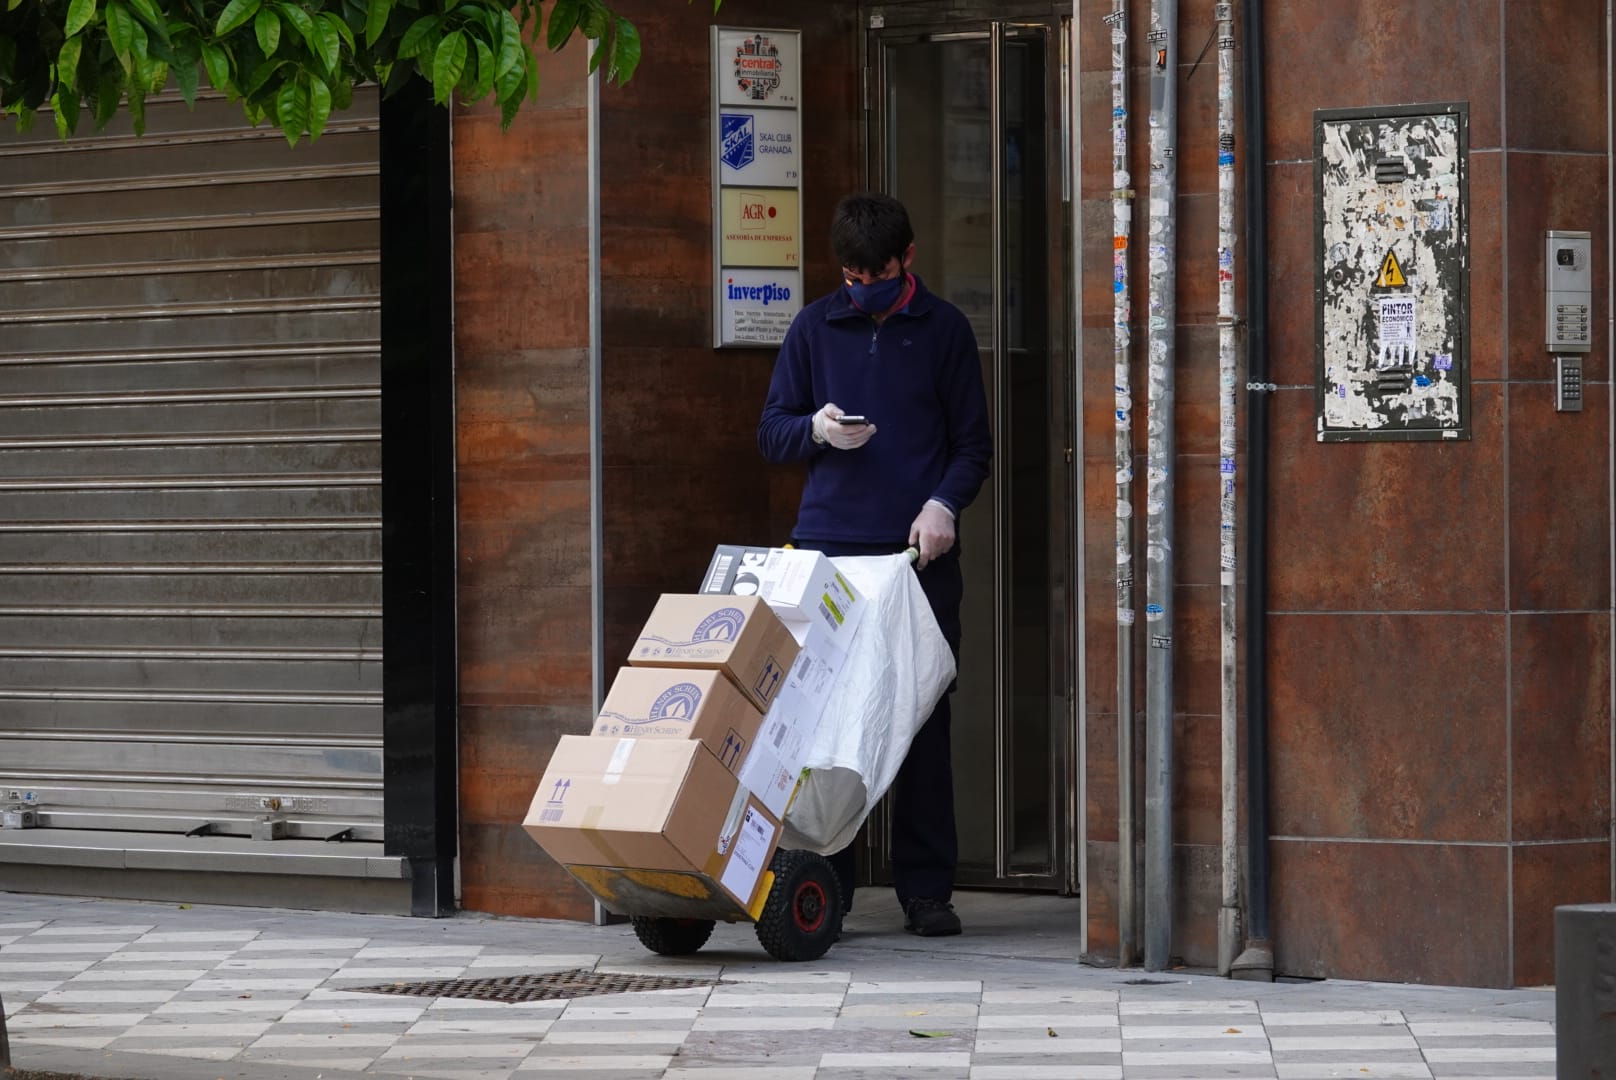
{"left": 1105, "top": 0, "right": 1139, "bottom": 967}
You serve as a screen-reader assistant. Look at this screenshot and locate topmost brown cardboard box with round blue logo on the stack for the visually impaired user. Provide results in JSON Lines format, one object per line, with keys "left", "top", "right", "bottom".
{"left": 629, "top": 593, "right": 797, "bottom": 711}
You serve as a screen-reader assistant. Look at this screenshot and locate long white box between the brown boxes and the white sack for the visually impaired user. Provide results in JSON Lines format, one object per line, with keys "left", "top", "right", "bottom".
{"left": 735, "top": 626, "right": 847, "bottom": 818}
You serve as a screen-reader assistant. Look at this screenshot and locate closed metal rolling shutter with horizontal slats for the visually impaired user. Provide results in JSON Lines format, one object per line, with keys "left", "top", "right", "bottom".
{"left": 0, "top": 94, "right": 381, "bottom": 852}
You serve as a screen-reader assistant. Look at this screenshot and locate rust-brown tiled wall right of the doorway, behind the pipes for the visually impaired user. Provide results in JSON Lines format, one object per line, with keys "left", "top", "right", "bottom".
{"left": 1083, "top": 0, "right": 1611, "bottom": 985}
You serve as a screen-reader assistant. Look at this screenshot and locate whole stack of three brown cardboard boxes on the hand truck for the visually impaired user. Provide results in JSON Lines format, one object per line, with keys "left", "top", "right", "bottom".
{"left": 524, "top": 595, "right": 798, "bottom": 918}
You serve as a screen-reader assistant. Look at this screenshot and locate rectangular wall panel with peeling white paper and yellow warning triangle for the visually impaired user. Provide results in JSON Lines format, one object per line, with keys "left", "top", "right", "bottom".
{"left": 1314, "top": 103, "right": 1471, "bottom": 443}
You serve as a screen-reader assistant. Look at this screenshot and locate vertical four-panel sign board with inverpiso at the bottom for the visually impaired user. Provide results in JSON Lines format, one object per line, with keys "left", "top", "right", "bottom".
{"left": 711, "top": 26, "right": 803, "bottom": 349}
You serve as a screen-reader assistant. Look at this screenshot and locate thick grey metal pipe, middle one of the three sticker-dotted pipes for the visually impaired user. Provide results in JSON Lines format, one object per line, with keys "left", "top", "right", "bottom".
{"left": 1144, "top": 0, "right": 1178, "bottom": 972}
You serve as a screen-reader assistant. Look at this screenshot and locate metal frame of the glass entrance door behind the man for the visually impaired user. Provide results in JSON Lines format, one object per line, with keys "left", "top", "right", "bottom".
{"left": 860, "top": 0, "right": 1086, "bottom": 892}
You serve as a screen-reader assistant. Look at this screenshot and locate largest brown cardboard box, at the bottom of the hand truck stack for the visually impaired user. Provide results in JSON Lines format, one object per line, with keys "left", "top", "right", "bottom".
{"left": 522, "top": 736, "right": 781, "bottom": 917}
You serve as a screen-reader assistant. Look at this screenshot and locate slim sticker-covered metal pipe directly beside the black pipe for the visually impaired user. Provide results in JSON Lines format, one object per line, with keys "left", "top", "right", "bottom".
{"left": 1212, "top": 3, "right": 1239, "bottom": 975}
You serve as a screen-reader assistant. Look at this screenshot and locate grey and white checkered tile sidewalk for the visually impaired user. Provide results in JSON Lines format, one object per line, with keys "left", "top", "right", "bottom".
{"left": 0, "top": 889, "right": 1555, "bottom": 1080}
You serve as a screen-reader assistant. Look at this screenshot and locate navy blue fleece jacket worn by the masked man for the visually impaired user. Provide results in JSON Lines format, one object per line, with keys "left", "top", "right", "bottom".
{"left": 758, "top": 278, "right": 992, "bottom": 546}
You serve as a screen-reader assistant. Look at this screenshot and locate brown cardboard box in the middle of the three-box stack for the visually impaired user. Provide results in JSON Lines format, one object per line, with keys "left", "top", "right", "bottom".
{"left": 593, "top": 668, "right": 763, "bottom": 773}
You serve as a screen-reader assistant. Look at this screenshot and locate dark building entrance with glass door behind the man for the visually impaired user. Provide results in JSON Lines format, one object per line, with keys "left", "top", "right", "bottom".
{"left": 863, "top": 0, "right": 1081, "bottom": 892}
